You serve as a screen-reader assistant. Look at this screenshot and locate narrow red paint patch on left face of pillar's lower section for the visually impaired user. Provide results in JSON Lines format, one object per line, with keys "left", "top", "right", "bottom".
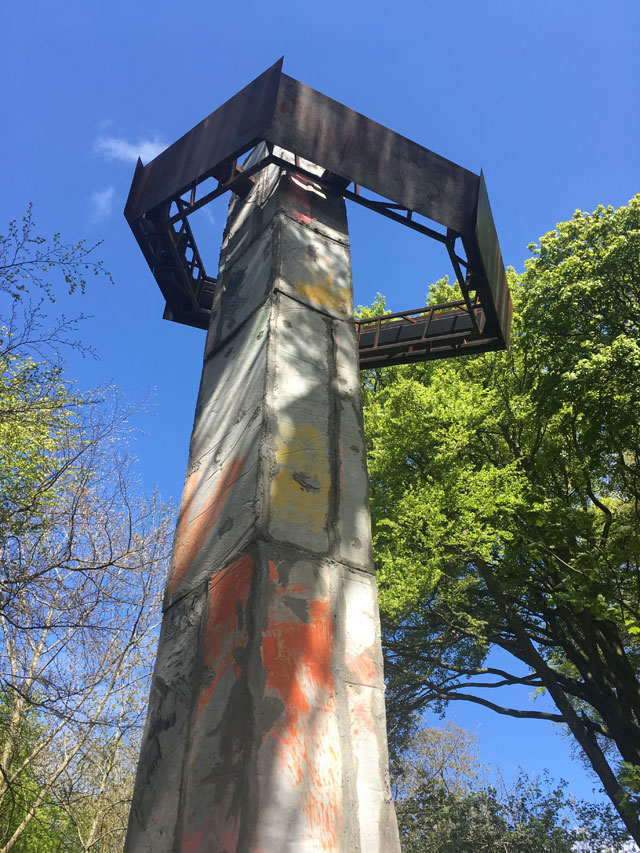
{"left": 198, "top": 554, "right": 253, "bottom": 717}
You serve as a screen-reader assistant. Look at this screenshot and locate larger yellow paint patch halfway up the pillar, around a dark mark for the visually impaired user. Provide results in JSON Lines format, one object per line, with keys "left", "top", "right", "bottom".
{"left": 271, "top": 421, "right": 331, "bottom": 533}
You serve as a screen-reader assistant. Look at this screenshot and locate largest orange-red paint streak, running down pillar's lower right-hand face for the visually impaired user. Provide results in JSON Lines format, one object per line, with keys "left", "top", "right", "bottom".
{"left": 255, "top": 562, "right": 342, "bottom": 851}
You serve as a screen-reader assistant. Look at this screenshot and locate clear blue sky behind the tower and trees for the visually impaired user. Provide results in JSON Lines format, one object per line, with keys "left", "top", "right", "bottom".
{"left": 0, "top": 0, "right": 640, "bottom": 794}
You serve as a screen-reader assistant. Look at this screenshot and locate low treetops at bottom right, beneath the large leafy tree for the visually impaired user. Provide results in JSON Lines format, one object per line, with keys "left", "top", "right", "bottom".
{"left": 392, "top": 723, "right": 626, "bottom": 853}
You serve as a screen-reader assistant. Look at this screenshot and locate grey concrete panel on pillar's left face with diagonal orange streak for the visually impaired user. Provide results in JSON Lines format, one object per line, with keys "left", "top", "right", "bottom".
{"left": 165, "top": 305, "right": 270, "bottom": 607}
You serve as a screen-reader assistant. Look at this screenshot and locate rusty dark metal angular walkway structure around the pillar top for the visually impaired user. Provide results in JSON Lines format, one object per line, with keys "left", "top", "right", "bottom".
{"left": 125, "top": 60, "right": 511, "bottom": 368}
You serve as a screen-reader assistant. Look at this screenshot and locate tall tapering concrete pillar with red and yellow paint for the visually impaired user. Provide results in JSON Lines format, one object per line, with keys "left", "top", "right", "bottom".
{"left": 126, "top": 152, "right": 400, "bottom": 853}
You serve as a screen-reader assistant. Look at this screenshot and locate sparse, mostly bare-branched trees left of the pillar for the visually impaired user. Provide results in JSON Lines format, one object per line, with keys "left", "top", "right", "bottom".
{"left": 0, "top": 211, "right": 173, "bottom": 853}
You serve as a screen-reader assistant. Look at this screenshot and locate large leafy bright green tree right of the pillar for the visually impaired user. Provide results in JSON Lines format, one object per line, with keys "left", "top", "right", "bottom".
{"left": 364, "top": 196, "right": 640, "bottom": 841}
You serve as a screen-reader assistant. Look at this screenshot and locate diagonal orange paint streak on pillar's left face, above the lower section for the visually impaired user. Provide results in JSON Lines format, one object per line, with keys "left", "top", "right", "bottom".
{"left": 167, "top": 456, "right": 246, "bottom": 595}
